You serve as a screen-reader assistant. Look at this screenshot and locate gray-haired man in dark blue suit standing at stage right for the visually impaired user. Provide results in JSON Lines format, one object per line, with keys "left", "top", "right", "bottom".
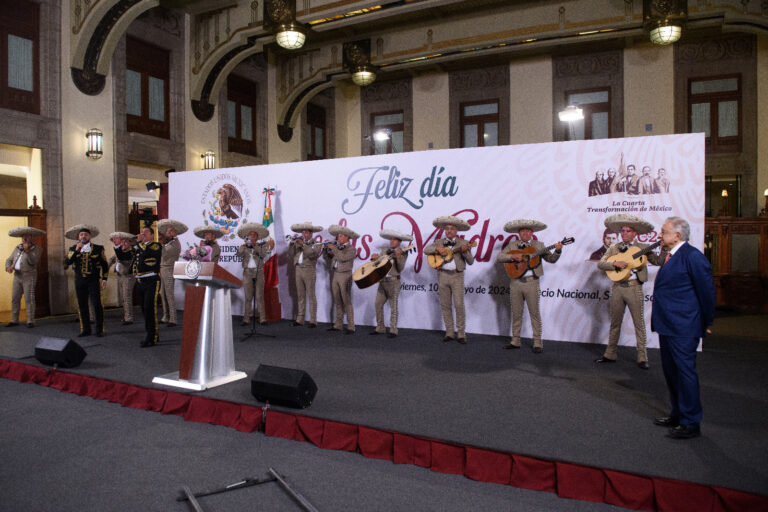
{"left": 651, "top": 217, "right": 715, "bottom": 439}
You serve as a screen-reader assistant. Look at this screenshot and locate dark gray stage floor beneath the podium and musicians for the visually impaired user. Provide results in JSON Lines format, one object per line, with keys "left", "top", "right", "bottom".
{"left": 0, "top": 311, "right": 768, "bottom": 508}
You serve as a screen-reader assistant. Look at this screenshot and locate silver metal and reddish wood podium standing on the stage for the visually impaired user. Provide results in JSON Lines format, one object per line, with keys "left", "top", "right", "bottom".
{"left": 152, "top": 260, "right": 247, "bottom": 391}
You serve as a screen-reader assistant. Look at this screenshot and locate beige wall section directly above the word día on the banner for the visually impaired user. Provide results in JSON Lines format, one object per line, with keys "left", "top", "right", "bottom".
{"left": 414, "top": 73, "right": 451, "bottom": 151}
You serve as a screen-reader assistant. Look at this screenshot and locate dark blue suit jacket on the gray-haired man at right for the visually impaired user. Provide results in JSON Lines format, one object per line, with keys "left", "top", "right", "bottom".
{"left": 651, "top": 242, "right": 715, "bottom": 338}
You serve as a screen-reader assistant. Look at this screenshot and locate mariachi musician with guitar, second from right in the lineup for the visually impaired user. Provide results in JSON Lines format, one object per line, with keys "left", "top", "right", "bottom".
{"left": 496, "top": 219, "right": 563, "bottom": 354}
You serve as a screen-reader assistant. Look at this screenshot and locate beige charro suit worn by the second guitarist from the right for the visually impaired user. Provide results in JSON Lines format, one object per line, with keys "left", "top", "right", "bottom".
{"left": 496, "top": 240, "right": 560, "bottom": 348}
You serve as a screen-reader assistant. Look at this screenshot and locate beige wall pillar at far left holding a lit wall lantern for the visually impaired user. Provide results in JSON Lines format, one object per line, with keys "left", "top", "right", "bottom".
{"left": 61, "top": 9, "right": 117, "bottom": 311}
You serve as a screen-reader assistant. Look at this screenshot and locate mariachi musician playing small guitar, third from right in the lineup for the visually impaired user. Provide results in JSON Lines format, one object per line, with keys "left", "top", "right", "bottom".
{"left": 424, "top": 215, "right": 475, "bottom": 345}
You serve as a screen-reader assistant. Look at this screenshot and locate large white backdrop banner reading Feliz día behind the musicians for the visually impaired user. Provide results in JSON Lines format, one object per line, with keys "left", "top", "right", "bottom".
{"left": 169, "top": 134, "right": 704, "bottom": 347}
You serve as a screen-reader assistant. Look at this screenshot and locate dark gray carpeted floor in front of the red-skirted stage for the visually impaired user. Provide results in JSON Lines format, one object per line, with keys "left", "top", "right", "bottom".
{"left": 0, "top": 379, "right": 623, "bottom": 512}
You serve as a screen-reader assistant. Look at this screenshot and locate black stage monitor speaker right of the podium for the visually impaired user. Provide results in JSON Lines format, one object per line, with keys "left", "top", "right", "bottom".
{"left": 251, "top": 364, "right": 317, "bottom": 409}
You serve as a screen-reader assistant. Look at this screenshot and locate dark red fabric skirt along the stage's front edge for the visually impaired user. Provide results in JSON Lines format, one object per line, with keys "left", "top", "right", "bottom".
{"left": 0, "top": 359, "right": 768, "bottom": 512}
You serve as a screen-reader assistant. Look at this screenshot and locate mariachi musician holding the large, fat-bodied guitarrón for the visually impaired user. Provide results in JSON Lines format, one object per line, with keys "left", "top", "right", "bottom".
{"left": 370, "top": 229, "right": 413, "bottom": 338}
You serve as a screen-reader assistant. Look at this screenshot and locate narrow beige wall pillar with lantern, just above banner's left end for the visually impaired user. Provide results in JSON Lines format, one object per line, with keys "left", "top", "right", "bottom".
{"left": 184, "top": 14, "right": 220, "bottom": 172}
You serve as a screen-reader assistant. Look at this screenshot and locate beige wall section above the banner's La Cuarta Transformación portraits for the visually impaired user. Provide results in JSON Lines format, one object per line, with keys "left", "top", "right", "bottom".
{"left": 624, "top": 43, "right": 675, "bottom": 137}
